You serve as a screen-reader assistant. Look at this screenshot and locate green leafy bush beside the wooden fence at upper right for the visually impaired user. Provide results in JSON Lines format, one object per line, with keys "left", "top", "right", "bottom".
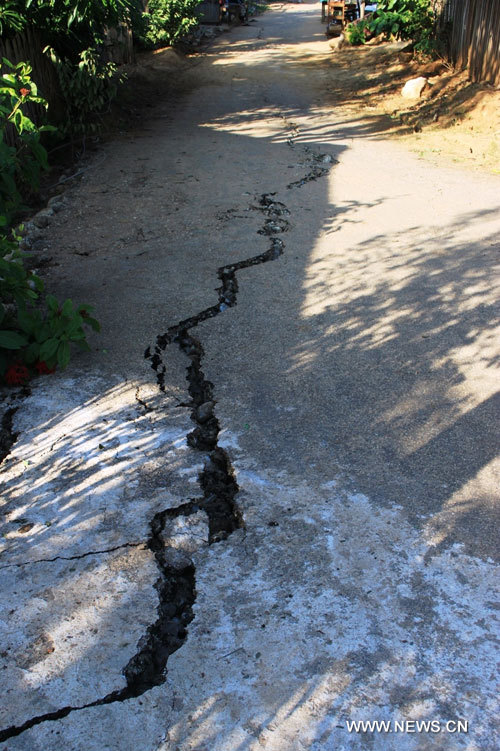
{"left": 369, "top": 0, "right": 435, "bottom": 51}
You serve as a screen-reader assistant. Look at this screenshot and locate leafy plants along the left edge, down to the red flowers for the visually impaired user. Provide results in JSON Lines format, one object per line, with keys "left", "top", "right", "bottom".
{"left": 0, "top": 59, "right": 99, "bottom": 384}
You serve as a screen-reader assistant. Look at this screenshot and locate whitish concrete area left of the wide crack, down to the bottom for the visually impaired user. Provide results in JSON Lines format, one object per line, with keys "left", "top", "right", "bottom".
{"left": 0, "top": 374, "right": 203, "bottom": 730}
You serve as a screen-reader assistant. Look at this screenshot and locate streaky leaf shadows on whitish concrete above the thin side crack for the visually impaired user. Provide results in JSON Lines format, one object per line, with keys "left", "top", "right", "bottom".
{"left": 0, "top": 378, "right": 191, "bottom": 568}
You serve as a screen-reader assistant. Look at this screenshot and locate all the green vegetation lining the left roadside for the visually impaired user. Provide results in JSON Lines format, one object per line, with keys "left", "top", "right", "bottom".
{"left": 0, "top": 0, "right": 207, "bottom": 386}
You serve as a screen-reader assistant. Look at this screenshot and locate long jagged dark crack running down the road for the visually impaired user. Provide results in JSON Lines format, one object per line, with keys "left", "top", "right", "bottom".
{"left": 0, "top": 118, "right": 336, "bottom": 743}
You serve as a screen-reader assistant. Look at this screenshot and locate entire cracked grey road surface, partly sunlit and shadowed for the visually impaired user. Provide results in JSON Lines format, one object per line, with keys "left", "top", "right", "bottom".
{"left": 0, "top": 3, "right": 500, "bottom": 751}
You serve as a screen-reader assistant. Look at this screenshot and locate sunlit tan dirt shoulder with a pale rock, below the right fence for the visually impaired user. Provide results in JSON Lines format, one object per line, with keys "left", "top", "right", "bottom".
{"left": 326, "top": 43, "right": 500, "bottom": 174}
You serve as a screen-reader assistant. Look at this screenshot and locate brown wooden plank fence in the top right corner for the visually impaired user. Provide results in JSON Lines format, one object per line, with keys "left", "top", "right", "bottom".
{"left": 434, "top": 0, "right": 500, "bottom": 85}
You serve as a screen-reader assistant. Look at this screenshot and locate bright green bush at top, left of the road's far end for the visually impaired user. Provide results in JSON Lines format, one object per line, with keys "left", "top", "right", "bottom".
{"left": 140, "top": 0, "right": 200, "bottom": 47}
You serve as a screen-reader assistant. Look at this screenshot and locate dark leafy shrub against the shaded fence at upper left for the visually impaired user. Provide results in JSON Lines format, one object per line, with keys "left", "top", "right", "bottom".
{"left": 45, "top": 48, "right": 123, "bottom": 137}
